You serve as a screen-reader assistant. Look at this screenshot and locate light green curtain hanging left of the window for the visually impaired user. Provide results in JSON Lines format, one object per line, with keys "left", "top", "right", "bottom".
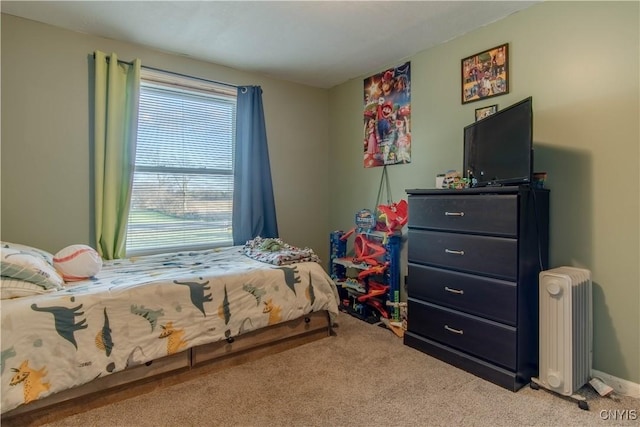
{"left": 93, "top": 51, "right": 140, "bottom": 259}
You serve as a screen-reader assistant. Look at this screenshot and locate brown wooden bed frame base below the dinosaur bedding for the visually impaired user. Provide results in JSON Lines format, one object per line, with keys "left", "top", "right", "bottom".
{"left": 1, "top": 311, "right": 332, "bottom": 427}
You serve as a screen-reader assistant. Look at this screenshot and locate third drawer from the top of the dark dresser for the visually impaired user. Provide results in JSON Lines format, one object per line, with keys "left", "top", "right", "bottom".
{"left": 408, "top": 263, "right": 518, "bottom": 326}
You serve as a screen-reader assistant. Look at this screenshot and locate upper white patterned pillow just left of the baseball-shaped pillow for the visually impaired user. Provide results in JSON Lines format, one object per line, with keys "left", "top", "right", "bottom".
{"left": 0, "top": 242, "right": 64, "bottom": 289}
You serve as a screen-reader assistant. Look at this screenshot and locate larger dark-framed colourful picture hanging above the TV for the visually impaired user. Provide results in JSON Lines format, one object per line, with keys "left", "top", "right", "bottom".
{"left": 461, "top": 43, "right": 509, "bottom": 104}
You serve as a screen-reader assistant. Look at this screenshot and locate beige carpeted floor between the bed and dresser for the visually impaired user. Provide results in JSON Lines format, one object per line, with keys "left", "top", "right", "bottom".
{"left": 42, "top": 314, "right": 640, "bottom": 427}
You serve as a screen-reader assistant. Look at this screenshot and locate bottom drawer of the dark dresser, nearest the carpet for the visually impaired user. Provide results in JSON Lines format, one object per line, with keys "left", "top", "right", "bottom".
{"left": 407, "top": 298, "right": 516, "bottom": 369}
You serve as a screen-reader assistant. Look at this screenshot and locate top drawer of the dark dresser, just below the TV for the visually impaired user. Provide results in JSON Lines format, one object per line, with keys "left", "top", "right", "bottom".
{"left": 409, "top": 194, "right": 518, "bottom": 237}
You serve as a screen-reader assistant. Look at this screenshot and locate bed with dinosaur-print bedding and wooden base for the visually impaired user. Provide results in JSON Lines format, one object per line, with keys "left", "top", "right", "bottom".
{"left": 0, "top": 243, "right": 338, "bottom": 424}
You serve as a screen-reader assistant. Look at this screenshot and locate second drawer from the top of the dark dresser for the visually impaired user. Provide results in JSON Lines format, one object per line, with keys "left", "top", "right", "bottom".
{"left": 408, "top": 229, "right": 518, "bottom": 280}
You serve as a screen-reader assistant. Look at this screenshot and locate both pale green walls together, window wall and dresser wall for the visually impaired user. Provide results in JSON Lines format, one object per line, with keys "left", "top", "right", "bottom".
{"left": 0, "top": 2, "right": 640, "bottom": 383}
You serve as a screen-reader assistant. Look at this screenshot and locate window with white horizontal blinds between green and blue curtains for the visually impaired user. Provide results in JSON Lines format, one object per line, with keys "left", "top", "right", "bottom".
{"left": 126, "top": 69, "right": 236, "bottom": 256}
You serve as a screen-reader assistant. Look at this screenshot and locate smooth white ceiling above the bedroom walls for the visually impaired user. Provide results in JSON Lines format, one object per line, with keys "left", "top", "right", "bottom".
{"left": 0, "top": 0, "right": 536, "bottom": 88}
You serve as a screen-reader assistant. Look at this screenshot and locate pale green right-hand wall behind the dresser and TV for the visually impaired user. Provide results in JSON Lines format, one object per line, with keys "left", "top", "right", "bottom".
{"left": 329, "top": 2, "right": 640, "bottom": 383}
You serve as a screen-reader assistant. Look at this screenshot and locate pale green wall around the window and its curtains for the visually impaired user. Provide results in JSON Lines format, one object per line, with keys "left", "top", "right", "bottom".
{"left": 1, "top": 14, "right": 329, "bottom": 260}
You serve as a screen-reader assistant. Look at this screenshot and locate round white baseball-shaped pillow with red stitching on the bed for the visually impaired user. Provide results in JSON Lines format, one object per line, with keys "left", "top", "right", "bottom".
{"left": 53, "top": 245, "right": 102, "bottom": 282}
